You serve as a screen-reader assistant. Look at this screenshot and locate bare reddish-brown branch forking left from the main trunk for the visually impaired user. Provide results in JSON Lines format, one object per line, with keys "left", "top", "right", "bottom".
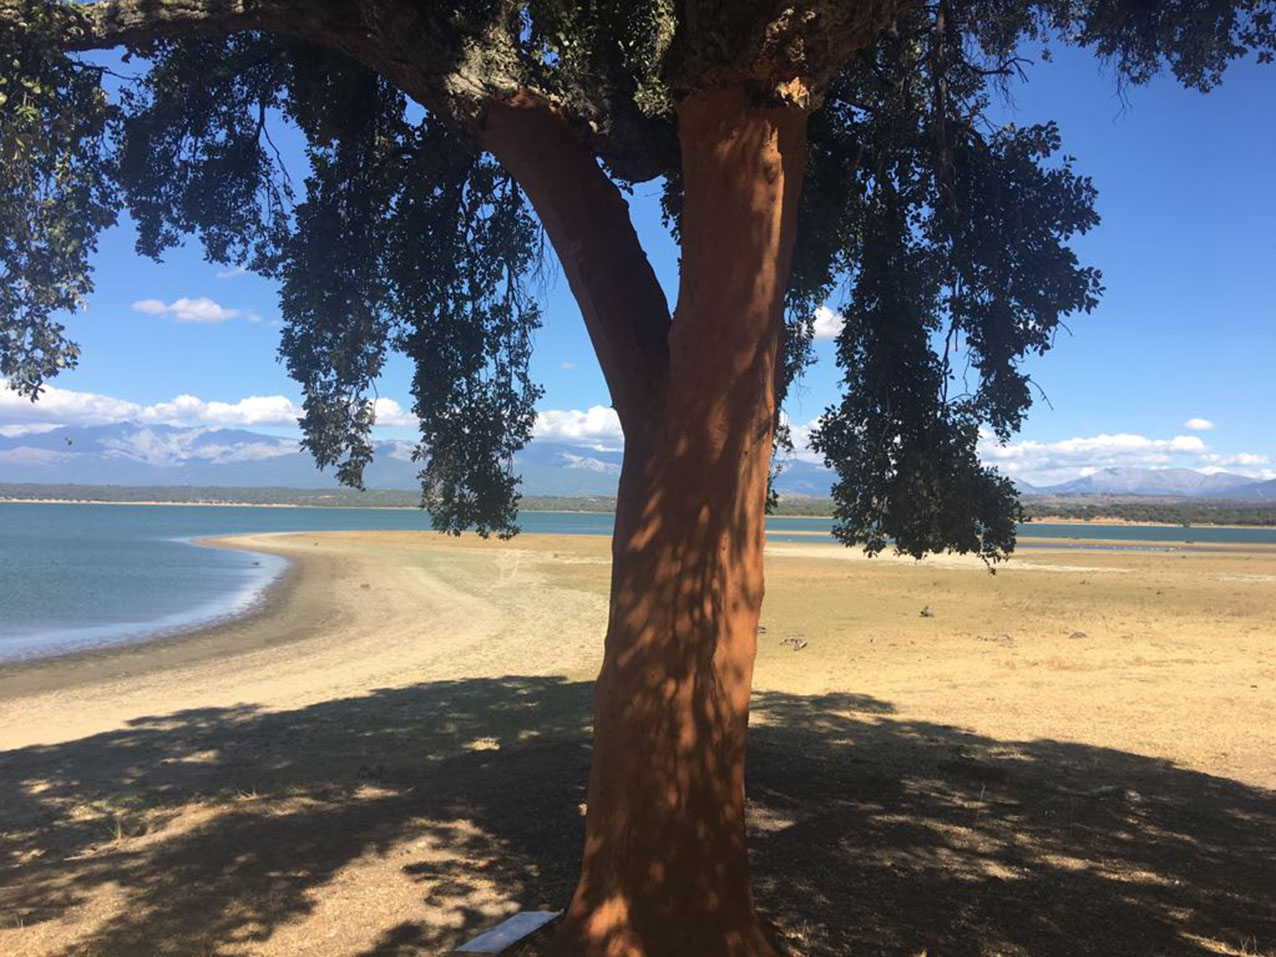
{"left": 480, "top": 93, "right": 670, "bottom": 427}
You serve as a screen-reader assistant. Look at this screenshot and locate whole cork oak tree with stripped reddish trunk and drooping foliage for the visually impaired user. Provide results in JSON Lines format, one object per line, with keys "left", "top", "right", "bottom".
{"left": 0, "top": 0, "right": 1276, "bottom": 954}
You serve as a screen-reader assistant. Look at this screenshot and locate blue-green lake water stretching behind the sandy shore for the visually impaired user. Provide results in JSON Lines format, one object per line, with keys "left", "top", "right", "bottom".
{"left": 0, "top": 503, "right": 1276, "bottom": 661}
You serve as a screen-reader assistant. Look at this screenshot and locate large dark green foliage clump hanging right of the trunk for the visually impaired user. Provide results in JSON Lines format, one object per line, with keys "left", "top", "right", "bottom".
{"left": 790, "top": 11, "right": 1100, "bottom": 561}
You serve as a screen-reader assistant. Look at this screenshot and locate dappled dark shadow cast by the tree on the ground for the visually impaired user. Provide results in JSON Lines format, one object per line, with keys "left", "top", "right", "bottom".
{"left": 0, "top": 676, "right": 1276, "bottom": 957}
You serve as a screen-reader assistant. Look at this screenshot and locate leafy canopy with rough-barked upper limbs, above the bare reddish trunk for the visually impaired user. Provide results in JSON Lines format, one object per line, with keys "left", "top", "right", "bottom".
{"left": 0, "top": 0, "right": 1276, "bottom": 560}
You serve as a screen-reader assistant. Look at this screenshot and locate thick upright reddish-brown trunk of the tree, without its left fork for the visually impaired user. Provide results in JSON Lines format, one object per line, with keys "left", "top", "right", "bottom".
{"left": 555, "top": 88, "right": 805, "bottom": 957}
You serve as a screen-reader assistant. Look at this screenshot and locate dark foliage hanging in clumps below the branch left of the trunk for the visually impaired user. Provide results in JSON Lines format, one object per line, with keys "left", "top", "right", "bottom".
{"left": 113, "top": 34, "right": 540, "bottom": 535}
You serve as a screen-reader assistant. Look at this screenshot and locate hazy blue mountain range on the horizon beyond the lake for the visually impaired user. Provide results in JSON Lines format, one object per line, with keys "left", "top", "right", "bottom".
{"left": 0, "top": 422, "right": 1276, "bottom": 500}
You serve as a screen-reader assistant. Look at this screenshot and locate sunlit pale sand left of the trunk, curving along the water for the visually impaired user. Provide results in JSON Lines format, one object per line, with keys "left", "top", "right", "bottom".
{"left": 0, "top": 532, "right": 605, "bottom": 749}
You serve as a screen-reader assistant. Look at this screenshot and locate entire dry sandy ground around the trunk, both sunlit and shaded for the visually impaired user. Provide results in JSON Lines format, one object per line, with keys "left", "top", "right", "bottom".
{"left": 0, "top": 533, "right": 1276, "bottom": 957}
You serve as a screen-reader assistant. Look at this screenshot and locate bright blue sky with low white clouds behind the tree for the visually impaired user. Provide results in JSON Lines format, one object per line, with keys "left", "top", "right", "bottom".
{"left": 0, "top": 50, "right": 1276, "bottom": 482}
